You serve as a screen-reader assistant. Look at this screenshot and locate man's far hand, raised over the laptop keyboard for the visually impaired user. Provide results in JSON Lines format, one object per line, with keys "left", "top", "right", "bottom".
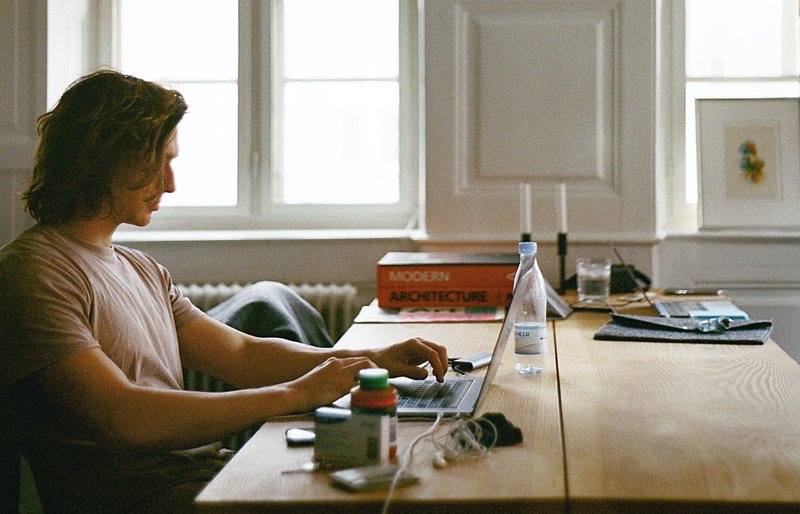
{"left": 367, "top": 337, "right": 447, "bottom": 382}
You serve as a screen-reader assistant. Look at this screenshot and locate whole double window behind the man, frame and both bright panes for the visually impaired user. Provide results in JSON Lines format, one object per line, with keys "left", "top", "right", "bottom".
{"left": 49, "top": 0, "right": 419, "bottom": 230}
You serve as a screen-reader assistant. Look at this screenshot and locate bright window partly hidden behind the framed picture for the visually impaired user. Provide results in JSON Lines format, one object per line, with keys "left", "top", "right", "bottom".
{"left": 670, "top": 0, "right": 800, "bottom": 225}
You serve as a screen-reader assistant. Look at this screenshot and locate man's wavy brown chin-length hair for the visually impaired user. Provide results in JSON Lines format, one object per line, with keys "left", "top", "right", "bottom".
{"left": 22, "top": 70, "right": 187, "bottom": 224}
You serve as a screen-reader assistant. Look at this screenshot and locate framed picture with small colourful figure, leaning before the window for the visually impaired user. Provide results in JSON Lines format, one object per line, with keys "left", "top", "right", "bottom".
{"left": 696, "top": 98, "right": 800, "bottom": 229}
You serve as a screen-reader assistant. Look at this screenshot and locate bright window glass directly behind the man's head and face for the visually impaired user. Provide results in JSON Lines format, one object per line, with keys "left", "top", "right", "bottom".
{"left": 117, "top": 0, "right": 239, "bottom": 207}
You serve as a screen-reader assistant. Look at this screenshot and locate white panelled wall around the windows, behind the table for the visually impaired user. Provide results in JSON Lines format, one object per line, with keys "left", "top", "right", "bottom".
{"left": 0, "top": 0, "right": 800, "bottom": 358}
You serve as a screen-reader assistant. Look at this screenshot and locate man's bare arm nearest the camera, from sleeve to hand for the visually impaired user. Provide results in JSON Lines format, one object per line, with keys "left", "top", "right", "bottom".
{"left": 24, "top": 342, "right": 372, "bottom": 450}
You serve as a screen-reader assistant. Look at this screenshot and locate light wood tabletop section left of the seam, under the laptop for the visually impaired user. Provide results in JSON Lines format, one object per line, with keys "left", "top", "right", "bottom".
{"left": 197, "top": 322, "right": 566, "bottom": 513}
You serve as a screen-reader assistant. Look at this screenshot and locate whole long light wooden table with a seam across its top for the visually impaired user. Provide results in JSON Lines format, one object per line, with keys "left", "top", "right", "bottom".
{"left": 198, "top": 312, "right": 800, "bottom": 513}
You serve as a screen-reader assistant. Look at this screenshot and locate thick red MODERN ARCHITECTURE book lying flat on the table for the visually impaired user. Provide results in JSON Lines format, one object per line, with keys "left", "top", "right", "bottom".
{"left": 377, "top": 252, "right": 519, "bottom": 309}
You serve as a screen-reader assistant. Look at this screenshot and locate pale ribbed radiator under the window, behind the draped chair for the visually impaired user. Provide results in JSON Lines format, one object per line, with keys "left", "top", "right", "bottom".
{"left": 178, "top": 284, "right": 358, "bottom": 450}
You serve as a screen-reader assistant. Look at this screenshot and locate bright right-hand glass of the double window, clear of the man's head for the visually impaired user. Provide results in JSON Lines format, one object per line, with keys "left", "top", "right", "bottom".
{"left": 273, "top": 0, "right": 400, "bottom": 204}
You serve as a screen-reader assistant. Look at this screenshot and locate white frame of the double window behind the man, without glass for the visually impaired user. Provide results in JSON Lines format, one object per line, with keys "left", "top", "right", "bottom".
{"left": 87, "top": 0, "right": 423, "bottom": 232}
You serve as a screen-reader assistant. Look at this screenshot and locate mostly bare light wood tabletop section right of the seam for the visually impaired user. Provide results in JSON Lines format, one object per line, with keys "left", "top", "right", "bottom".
{"left": 555, "top": 313, "right": 800, "bottom": 513}
